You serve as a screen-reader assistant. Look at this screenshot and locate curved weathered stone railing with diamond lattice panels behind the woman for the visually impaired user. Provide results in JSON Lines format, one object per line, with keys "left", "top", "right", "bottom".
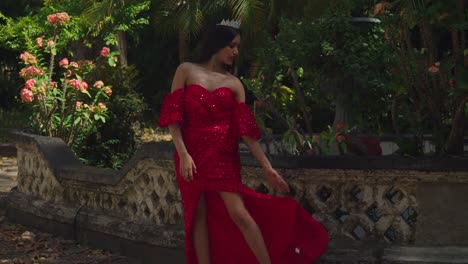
{"left": 8, "top": 133, "right": 468, "bottom": 263}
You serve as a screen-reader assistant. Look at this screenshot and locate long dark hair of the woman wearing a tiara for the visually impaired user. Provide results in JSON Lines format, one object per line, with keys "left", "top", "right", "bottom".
{"left": 197, "top": 25, "right": 240, "bottom": 63}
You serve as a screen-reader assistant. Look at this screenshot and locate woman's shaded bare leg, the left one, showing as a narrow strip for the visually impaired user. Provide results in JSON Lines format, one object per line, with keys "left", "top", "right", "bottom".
{"left": 193, "top": 193, "right": 210, "bottom": 264}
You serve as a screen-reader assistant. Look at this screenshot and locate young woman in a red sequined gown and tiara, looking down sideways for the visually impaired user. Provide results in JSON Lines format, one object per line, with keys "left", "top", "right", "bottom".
{"left": 158, "top": 20, "right": 328, "bottom": 264}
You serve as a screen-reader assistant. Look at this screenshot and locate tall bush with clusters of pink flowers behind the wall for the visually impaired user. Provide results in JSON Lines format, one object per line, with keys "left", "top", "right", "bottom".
{"left": 19, "top": 12, "right": 117, "bottom": 146}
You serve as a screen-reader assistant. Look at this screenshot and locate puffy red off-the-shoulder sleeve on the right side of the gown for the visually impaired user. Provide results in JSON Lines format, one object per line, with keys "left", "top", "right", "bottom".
{"left": 231, "top": 102, "right": 262, "bottom": 139}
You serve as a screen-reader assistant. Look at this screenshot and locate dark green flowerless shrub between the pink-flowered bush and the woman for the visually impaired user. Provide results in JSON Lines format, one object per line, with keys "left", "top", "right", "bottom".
{"left": 79, "top": 67, "right": 147, "bottom": 168}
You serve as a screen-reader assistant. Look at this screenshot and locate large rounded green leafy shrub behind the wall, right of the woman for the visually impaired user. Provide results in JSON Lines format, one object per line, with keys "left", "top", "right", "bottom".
{"left": 250, "top": 3, "right": 391, "bottom": 154}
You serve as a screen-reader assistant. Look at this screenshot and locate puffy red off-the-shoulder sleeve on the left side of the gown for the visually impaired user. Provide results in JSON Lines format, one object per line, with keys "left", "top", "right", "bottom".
{"left": 158, "top": 89, "right": 184, "bottom": 127}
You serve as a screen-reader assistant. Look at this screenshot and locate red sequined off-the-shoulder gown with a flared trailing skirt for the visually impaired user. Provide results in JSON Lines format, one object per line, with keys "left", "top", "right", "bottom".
{"left": 158, "top": 84, "right": 329, "bottom": 264}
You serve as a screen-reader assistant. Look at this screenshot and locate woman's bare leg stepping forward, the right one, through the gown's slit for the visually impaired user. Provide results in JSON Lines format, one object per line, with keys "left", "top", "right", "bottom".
{"left": 219, "top": 192, "right": 271, "bottom": 264}
